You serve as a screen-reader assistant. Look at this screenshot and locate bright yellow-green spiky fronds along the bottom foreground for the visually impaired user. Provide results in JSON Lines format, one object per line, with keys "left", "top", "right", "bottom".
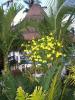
{"left": 13, "top": 67, "right": 63, "bottom": 100}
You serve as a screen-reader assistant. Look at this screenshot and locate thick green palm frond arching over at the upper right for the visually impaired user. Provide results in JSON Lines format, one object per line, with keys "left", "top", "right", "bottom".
{"left": 55, "top": 4, "right": 75, "bottom": 38}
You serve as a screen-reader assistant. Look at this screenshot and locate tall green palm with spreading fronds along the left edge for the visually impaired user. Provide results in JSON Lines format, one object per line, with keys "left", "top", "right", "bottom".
{"left": 0, "top": 6, "right": 25, "bottom": 72}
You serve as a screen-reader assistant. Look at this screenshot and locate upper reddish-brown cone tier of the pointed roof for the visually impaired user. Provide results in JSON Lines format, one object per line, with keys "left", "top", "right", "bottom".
{"left": 25, "top": 4, "right": 46, "bottom": 20}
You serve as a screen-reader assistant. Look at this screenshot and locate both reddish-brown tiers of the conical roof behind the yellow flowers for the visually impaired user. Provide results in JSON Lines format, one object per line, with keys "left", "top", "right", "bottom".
{"left": 23, "top": 4, "right": 46, "bottom": 40}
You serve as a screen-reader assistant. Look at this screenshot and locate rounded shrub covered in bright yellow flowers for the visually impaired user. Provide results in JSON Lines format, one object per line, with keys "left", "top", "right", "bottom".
{"left": 21, "top": 33, "right": 63, "bottom": 63}
